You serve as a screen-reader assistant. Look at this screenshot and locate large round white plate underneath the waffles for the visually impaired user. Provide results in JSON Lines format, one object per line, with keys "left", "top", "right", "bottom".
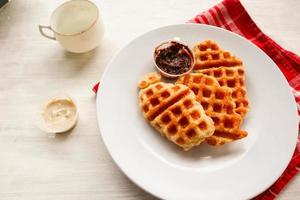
{"left": 97, "top": 24, "right": 298, "bottom": 199}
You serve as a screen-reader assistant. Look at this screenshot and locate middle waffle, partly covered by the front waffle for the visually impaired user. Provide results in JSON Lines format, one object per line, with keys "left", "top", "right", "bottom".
{"left": 176, "top": 73, "right": 247, "bottom": 146}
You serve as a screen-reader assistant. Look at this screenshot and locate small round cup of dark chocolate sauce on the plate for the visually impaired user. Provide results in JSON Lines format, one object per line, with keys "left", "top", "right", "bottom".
{"left": 153, "top": 40, "right": 195, "bottom": 78}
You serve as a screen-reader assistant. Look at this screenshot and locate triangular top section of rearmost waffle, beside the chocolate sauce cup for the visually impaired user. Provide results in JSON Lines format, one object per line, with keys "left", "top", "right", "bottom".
{"left": 194, "top": 40, "right": 243, "bottom": 70}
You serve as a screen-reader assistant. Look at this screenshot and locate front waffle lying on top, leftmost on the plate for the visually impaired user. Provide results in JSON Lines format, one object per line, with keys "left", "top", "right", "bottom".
{"left": 139, "top": 73, "right": 215, "bottom": 150}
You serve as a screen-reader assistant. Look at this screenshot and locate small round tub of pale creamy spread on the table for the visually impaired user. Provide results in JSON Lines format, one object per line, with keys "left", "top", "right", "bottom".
{"left": 42, "top": 97, "right": 77, "bottom": 133}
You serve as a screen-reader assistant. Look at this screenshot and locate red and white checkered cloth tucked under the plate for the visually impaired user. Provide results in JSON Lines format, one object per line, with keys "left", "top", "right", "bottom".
{"left": 93, "top": 0, "right": 300, "bottom": 200}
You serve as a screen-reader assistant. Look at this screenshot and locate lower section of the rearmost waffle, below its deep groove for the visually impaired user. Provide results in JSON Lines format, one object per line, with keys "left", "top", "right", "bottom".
{"left": 198, "top": 66, "right": 249, "bottom": 117}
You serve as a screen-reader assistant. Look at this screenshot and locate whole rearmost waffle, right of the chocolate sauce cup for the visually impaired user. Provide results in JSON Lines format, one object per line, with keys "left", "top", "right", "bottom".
{"left": 194, "top": 40, "right": 249, "bottom": 117}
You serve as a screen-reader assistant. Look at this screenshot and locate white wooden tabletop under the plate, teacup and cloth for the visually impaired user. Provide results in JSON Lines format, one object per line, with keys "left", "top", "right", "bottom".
{"left": 0, "top": 0, "right": 300, "bottom": 200}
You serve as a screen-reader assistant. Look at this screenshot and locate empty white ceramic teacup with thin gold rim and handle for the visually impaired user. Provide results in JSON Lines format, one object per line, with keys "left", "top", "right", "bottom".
{"left": 39, "top": 0, "right": 104, "bottom": 53}
